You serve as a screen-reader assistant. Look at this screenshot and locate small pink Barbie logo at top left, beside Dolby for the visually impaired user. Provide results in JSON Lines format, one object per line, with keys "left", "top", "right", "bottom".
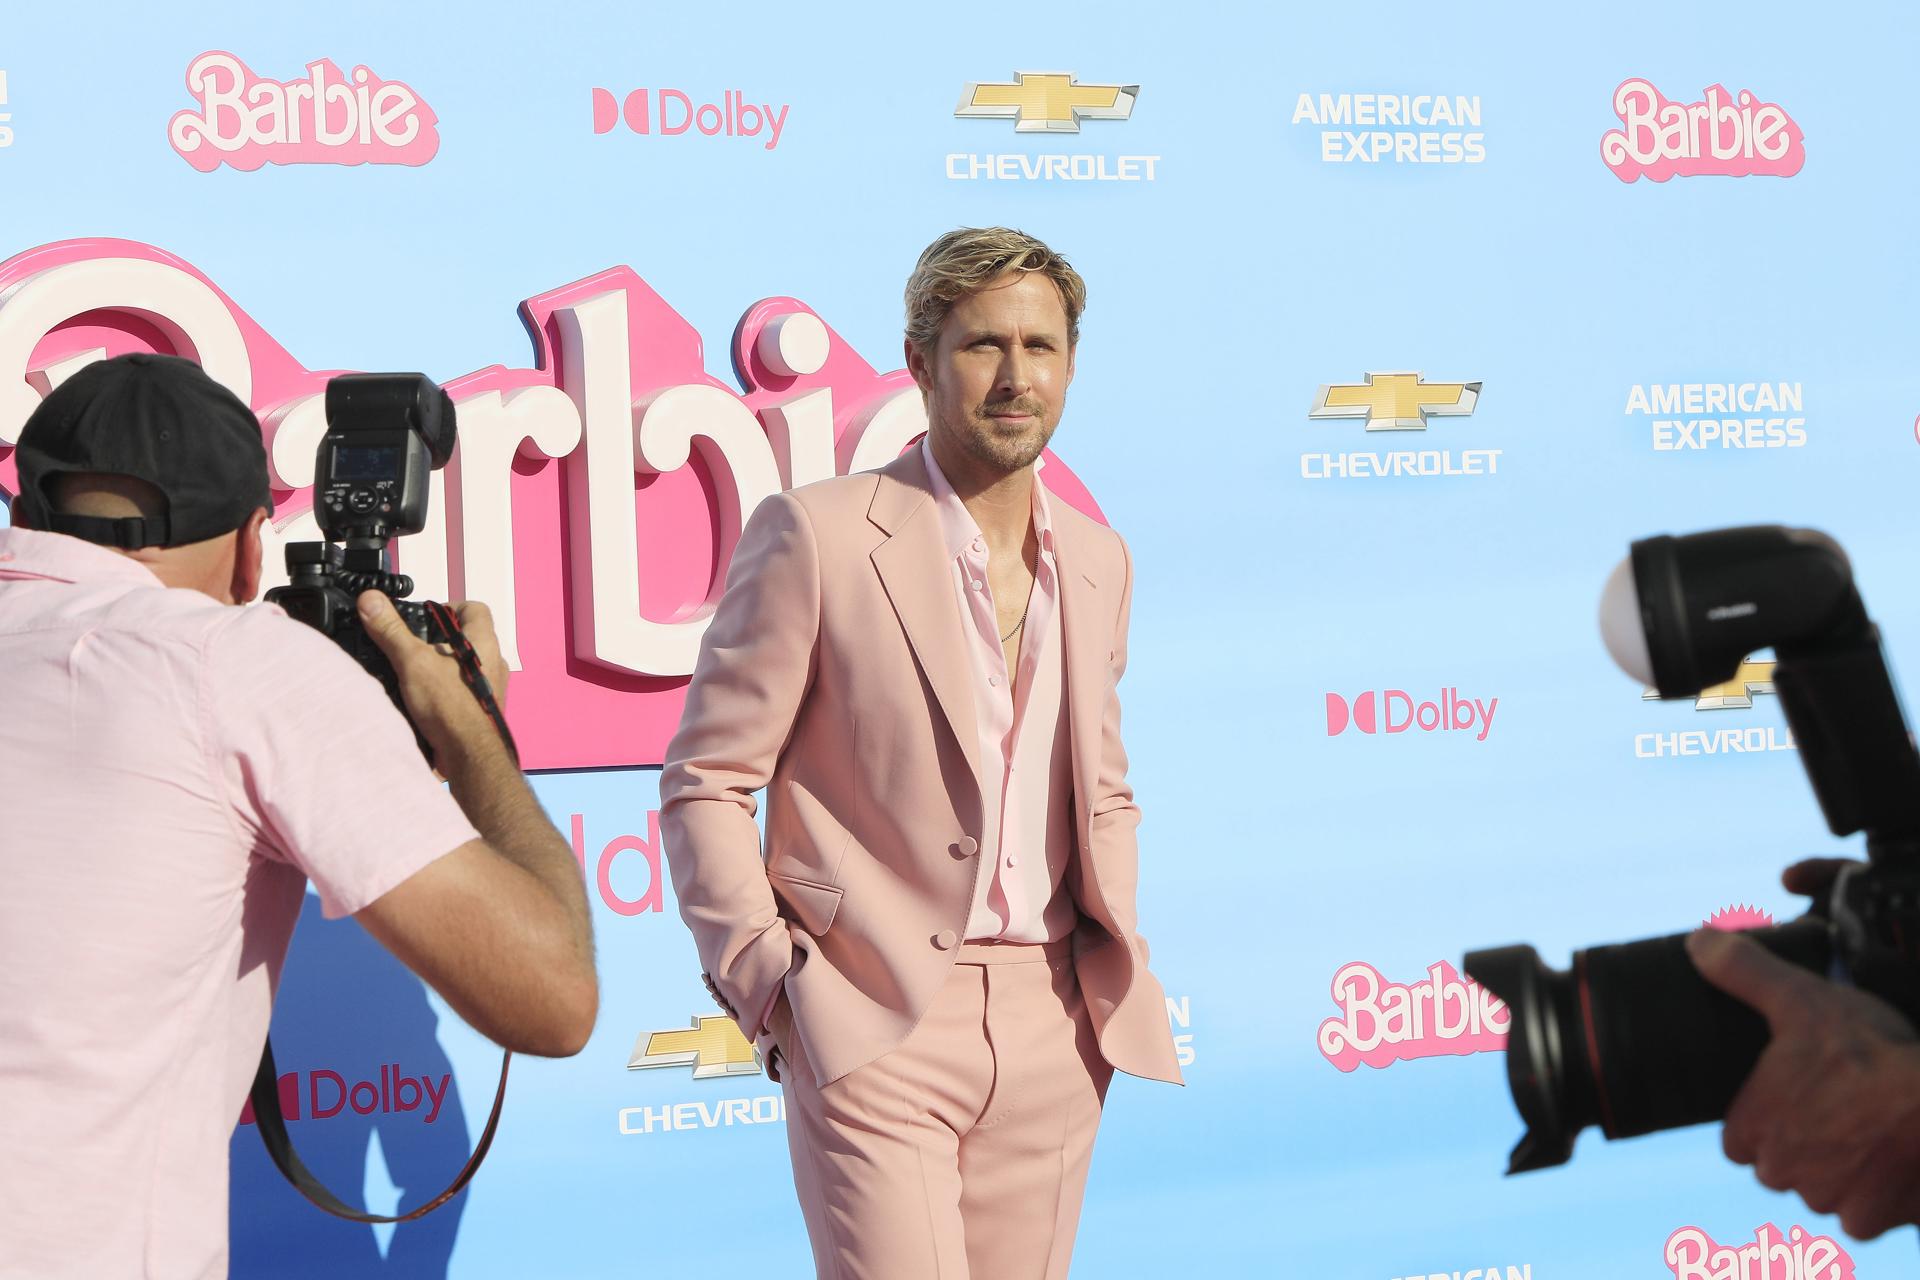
{"left": 167, "top": 50, "right": 440, "bottom": 173}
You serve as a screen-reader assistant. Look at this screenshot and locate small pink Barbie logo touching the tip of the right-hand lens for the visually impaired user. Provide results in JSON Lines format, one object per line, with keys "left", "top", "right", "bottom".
{"left": 1319, "top": 960, "right": 1513, "bottom": 1071}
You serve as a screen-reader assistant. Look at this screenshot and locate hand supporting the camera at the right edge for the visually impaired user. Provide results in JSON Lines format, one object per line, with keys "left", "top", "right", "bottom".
{"left": 1688, "top": 932, "right": 1920, "bottom": 1240}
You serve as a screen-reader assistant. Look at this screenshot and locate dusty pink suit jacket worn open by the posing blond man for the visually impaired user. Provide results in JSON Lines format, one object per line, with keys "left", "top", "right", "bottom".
{"left": 660, "top": 449, "right": 1181, "bottom": 1086}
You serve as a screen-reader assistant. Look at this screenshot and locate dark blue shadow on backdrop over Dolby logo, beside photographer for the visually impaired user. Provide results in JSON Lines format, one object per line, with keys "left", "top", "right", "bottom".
{"left": 228, "top": 894, "right": 470, "bottom": 1280}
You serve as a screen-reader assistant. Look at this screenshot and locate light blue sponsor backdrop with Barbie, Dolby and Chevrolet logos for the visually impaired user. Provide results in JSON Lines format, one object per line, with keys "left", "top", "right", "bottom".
{"left": 0, "top": 0, "right": 1920, "bottom": 1280}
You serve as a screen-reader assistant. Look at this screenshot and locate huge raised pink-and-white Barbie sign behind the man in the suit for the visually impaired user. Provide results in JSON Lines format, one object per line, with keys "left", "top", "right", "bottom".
{"left": 0, "top": 240, "right": 1100, "bottom": 771}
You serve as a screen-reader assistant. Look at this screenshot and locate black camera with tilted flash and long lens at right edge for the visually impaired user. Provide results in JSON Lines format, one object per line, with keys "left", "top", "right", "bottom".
{"left": 1465, "top": 526, "right": 1920, "bottom": 1173}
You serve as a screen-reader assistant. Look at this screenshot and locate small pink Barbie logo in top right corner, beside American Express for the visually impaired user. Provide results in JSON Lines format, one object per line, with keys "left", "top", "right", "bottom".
{"left": 1599, "top": 79, "right": 1807, "bottom": 182}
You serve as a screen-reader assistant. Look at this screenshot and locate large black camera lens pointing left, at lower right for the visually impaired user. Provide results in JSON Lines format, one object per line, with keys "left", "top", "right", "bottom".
{"left": 1465, "top": 917, "right": 1832, "bottom": 1173}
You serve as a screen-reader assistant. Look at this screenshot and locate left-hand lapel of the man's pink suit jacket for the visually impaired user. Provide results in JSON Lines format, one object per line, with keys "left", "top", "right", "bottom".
{"left": 868, "top": 449, "right": 979, "bottom": 785}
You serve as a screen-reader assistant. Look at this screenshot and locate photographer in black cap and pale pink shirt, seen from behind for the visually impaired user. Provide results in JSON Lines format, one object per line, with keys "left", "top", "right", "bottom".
{"left": 0, "top": 355, "right": 599, "bottom": 1280}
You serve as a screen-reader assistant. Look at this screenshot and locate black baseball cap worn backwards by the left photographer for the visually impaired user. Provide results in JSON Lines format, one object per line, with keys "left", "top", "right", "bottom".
{"left": 13, "top": 351, "right": 273, "bottom": 551}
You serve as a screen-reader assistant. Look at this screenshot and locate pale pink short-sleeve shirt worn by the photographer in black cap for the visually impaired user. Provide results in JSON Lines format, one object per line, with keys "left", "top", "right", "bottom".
{"left": 0, "top": 530, "right": 474, "bottom": 1280}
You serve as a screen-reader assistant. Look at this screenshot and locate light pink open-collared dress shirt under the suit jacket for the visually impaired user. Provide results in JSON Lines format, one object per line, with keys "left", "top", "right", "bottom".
{"left": 920, "top": 441, "right": 1077, "bottom": 942}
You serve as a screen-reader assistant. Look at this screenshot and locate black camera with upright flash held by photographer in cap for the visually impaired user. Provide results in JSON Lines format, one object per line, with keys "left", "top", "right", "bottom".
{"left": 267, "top": 374, "right": 463, "bottom": 754}
